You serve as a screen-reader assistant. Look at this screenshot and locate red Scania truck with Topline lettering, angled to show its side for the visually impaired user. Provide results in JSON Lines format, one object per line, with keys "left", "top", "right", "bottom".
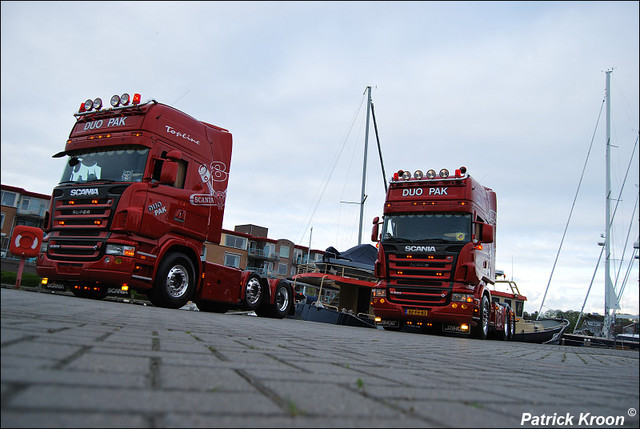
{"left": 37, "top": 94, "right": 293, "bottom": 318}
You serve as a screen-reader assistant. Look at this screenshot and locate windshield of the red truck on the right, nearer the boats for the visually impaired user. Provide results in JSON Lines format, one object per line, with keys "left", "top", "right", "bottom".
{"left": 382, "top": 213, "right": 471, "bottom": 243}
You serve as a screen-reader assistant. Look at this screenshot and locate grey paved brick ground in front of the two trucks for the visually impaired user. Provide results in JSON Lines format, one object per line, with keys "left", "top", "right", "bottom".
{"left": 1, "top": 288, "right": 639, "bottom": 427}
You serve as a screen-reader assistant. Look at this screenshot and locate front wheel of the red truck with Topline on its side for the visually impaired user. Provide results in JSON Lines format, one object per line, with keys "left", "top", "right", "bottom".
{"left": 149, "top": 253, "right": 196, "bottom": 308}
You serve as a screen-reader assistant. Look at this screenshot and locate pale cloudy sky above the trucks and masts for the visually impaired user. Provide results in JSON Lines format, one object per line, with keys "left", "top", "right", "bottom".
{"left": 1, "top": 1, "right": 640, "bottom": 314}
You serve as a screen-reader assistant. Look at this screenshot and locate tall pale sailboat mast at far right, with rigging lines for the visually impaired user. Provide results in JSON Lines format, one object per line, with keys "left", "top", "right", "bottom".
{"left": 602, "top": 70, "right": 613, "bottom": 338}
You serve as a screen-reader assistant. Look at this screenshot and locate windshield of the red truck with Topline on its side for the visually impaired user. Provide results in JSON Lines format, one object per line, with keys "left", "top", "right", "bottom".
{"left": 60, "top": 147, "right": 149, "bottom": 183}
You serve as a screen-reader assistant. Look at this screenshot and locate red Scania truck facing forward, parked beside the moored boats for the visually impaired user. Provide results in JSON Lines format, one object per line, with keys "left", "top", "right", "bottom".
{"left": 371, "top": 167, "right": 515, "bottom": 339}
